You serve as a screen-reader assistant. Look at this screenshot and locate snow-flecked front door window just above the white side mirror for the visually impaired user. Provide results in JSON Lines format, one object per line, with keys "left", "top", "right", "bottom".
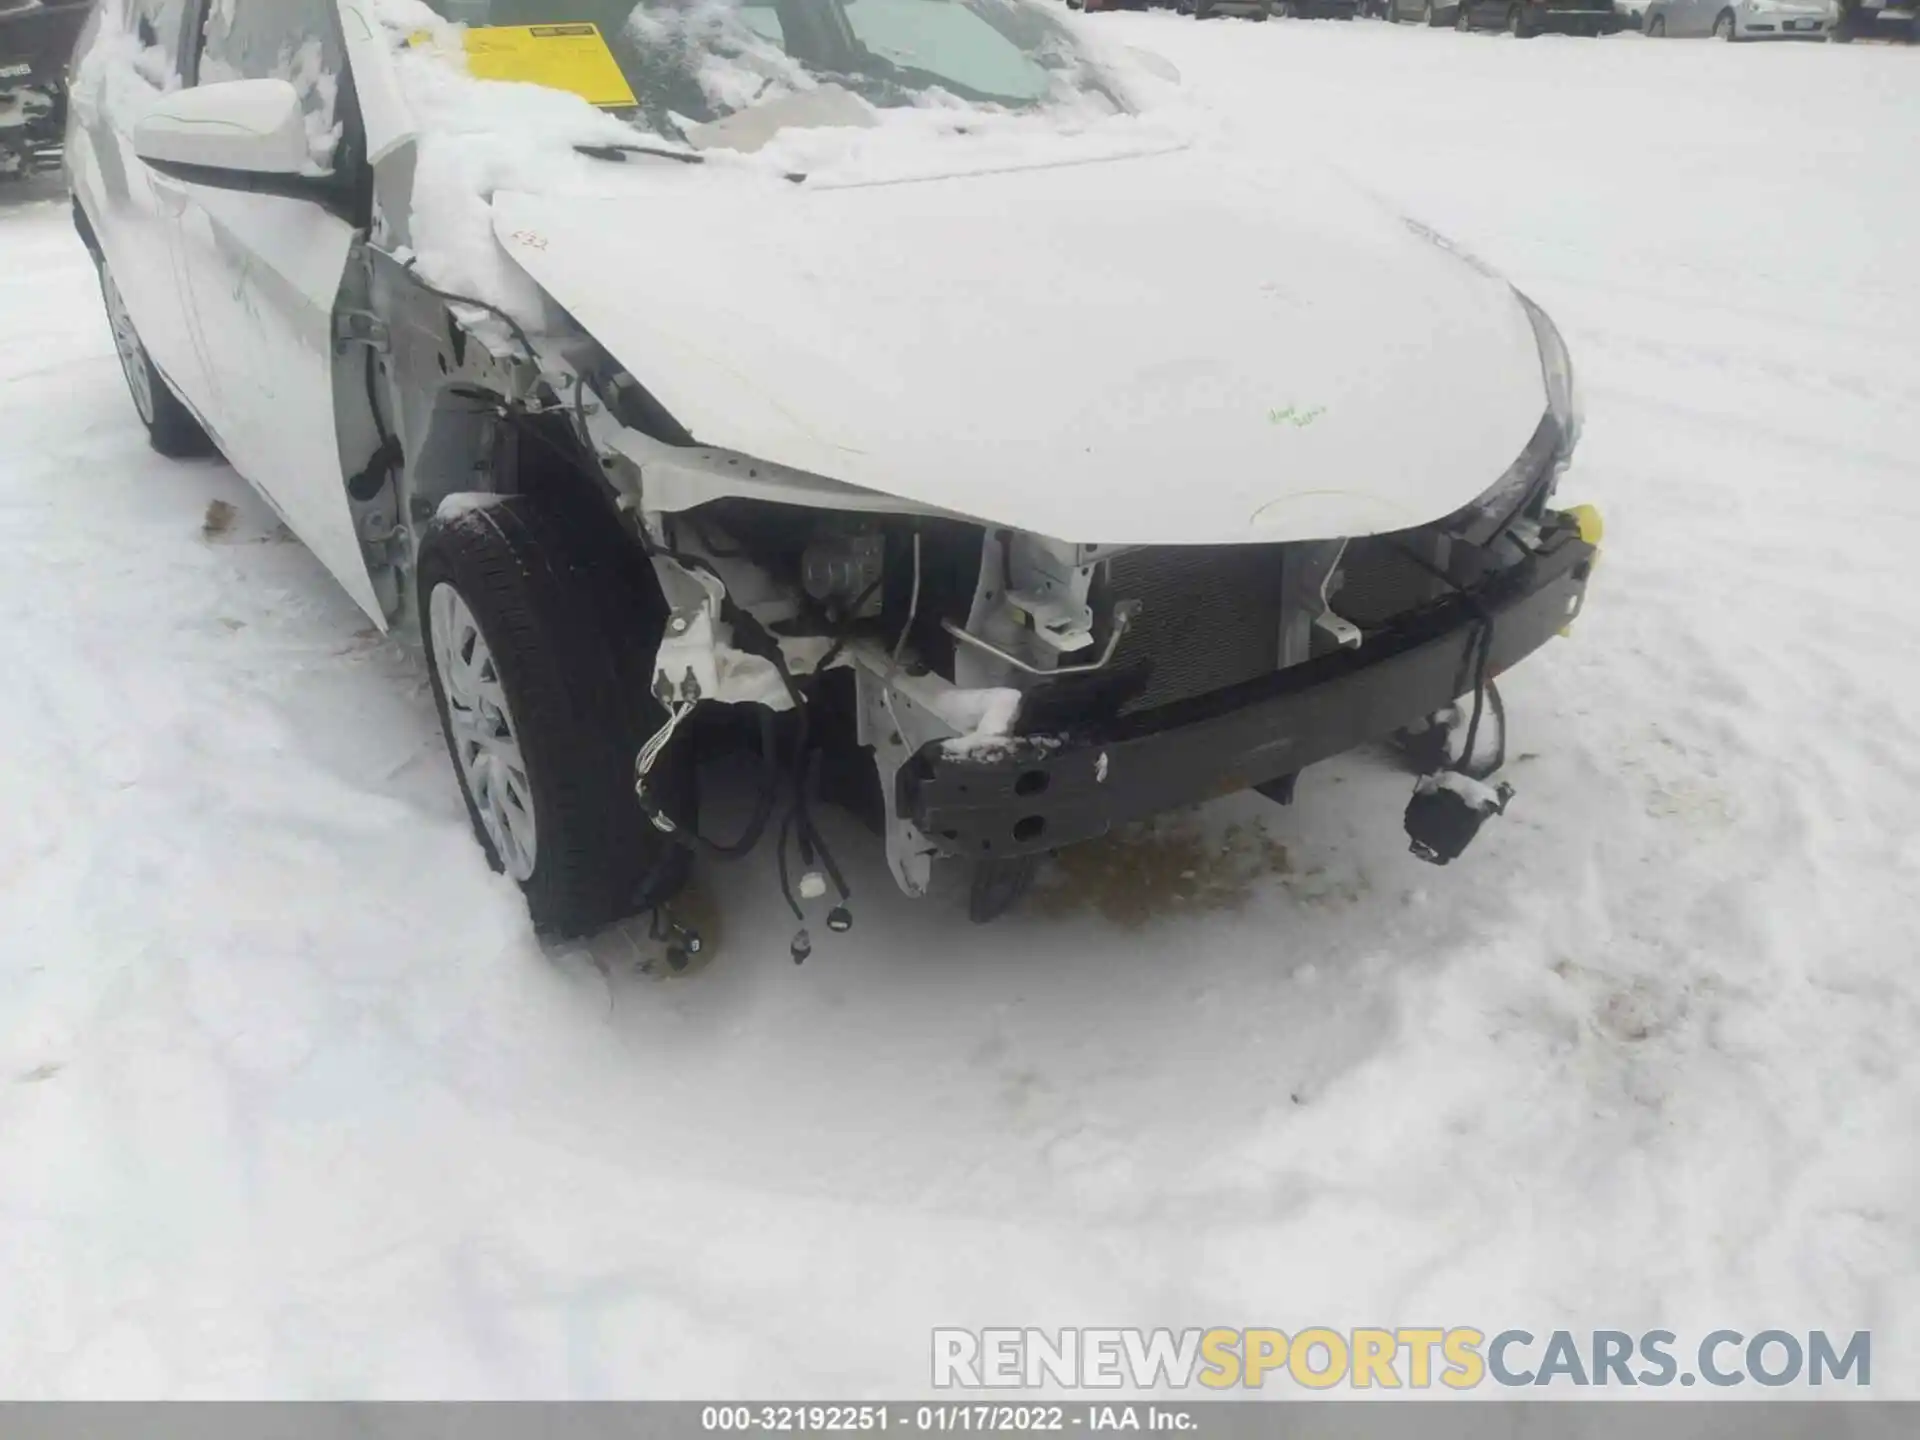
{"left": 198, "top": 0, "right": 346, "bottom": 171}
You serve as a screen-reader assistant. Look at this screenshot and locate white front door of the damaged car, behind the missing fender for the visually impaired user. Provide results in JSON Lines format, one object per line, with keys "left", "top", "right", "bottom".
{"left": 154, "top": 0, "right": 384, "bottom": 624}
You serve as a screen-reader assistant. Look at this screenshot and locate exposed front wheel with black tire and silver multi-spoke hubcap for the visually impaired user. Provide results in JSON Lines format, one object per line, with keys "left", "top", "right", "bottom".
{"left": 419, "top": 495, "right": 693, "bottom": 935}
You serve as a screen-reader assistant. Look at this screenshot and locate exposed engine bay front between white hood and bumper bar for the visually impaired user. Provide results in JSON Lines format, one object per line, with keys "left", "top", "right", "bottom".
{"left": 622, "top": 486, "right": 1546, "bottom": 913}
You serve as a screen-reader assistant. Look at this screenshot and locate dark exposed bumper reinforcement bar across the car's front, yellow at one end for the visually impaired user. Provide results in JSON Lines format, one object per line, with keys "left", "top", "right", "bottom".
{"left": 895, "top": 522, "right": 1597, "bottom": 860}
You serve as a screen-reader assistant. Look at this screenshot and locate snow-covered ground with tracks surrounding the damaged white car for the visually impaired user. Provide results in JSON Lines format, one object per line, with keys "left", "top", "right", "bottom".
{"left": 0, "top": 13, "right": 1920, "bottom": 1396}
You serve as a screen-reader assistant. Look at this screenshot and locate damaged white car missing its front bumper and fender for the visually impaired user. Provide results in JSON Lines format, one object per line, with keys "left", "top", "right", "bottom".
{"left": 67, "top": 0, "right": 1599, "bottom": 958}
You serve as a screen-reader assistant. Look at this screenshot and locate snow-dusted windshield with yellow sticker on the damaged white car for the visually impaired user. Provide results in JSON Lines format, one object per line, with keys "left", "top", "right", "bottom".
{"left": 418, "top": 0, "right": 1123, "bottom": 134}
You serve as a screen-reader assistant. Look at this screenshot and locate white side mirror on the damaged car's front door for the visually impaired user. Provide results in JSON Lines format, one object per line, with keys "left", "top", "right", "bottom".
{"left": 132, "top": 81, "right": 323, "bottom": 190}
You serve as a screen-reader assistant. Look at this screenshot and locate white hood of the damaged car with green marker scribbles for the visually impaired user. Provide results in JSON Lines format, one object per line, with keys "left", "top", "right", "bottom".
{"left": 493, "top": 150, "right": 1546, "bottom": 545}
